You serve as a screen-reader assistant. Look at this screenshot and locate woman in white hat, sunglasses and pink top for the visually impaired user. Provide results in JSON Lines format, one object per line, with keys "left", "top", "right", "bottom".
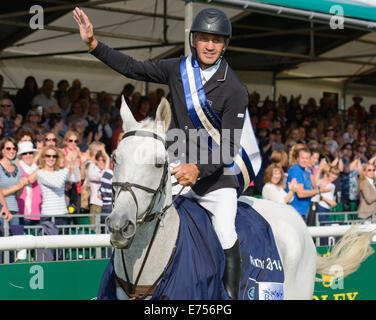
{"left": 17, "top": 141, "right": 42, "bottom": 226}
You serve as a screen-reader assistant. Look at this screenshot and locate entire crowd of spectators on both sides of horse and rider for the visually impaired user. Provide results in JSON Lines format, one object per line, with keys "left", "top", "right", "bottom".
{"left": 0, "top": 75, "right": 376, "bottom": 248}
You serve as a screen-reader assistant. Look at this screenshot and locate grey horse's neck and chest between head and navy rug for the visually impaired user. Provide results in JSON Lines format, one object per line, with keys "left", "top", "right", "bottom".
{"left": 114, "top": 176, "right": 180, "bottom": 285}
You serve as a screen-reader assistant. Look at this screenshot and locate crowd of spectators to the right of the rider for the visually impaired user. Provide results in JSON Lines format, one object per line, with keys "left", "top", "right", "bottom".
{"left": 253, "top": 92, "right": 376, "bottom": 224}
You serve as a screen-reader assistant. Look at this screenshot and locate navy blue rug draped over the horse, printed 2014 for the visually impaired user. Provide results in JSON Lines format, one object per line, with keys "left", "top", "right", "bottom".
{"left": 98, "top": 196, "right": 284, "bottom": 300}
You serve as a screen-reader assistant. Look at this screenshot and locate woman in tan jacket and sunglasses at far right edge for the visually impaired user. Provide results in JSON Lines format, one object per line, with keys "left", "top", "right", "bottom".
{"left": 358, "top": 163, "right": 376, "bottom": 220}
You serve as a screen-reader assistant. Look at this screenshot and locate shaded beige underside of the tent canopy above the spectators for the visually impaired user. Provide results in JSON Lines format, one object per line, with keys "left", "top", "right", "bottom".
{"left": 0, "top": 0, "right": 376, "bottom": 106}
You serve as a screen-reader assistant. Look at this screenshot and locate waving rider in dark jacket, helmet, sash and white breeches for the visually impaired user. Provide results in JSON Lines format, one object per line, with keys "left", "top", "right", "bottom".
{"left": 74, "top": 8, "right": 250, "bottom": 299}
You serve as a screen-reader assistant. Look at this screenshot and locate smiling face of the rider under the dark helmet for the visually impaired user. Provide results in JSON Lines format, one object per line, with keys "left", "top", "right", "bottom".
{"left": 193, "top": 32, "right": 225, "bottom": 69}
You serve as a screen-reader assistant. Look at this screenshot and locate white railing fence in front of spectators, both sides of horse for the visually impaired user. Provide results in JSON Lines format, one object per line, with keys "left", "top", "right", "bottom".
{"left": 0, "top": 213, "right": 376, "bottom": 264}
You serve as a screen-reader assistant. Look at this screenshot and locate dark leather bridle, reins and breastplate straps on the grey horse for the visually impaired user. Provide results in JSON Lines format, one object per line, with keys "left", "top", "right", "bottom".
{"left": 112, "top": 130, "right": 184, "bottom": 300}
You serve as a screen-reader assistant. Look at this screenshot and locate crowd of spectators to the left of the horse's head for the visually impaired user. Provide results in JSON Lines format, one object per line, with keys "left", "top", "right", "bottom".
{"left": 0, "top": 75, "right": 164, "bottom": 252}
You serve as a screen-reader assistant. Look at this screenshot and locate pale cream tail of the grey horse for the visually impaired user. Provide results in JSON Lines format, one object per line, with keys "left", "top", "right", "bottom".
{"left": 316, "top": 226, "right": 374, "bottom": 281}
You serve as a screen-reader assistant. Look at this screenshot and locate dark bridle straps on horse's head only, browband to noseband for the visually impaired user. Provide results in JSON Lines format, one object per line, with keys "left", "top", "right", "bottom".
{"left": 112, "top": 130, "right": 170, "bottom": 224}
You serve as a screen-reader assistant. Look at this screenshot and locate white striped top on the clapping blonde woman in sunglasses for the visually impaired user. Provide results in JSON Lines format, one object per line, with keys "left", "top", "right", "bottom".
{"left": 37, "top": 166, "right": 81, "bottom": 216}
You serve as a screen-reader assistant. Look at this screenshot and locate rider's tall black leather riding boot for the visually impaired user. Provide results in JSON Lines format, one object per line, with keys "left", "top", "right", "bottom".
{"left": 223, "top": 239, "right": 241, "bottom": 300}
